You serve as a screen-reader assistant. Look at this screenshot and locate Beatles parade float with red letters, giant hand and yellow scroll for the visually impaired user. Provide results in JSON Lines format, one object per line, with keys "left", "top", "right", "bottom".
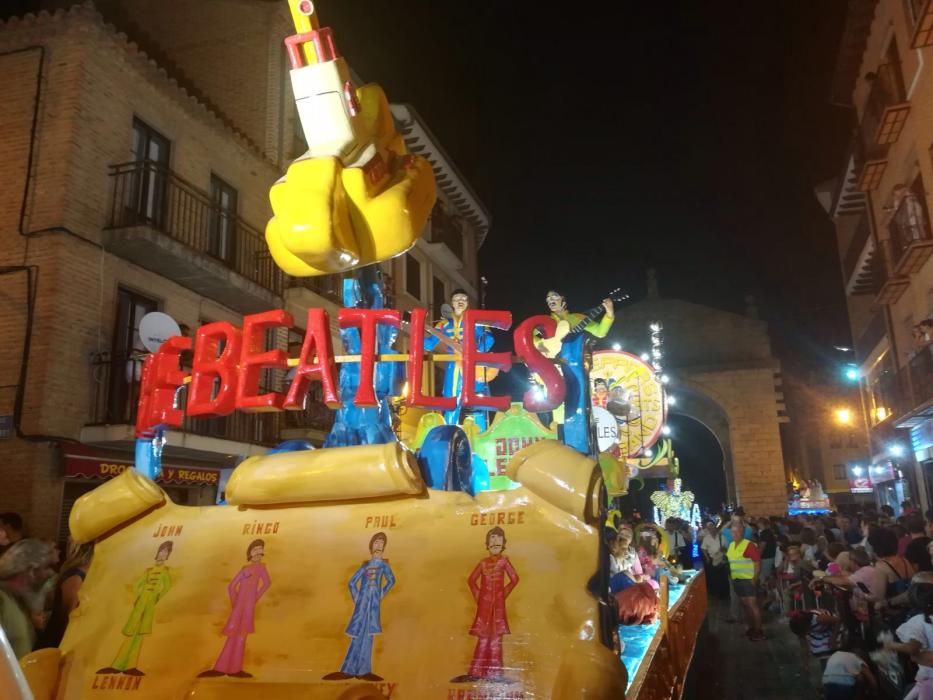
{"left": 0, "top": 0, "right": 706, "bottom": 700}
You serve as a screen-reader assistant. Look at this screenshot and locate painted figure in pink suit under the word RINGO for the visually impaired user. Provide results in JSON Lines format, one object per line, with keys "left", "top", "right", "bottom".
{"left": 198, "top": 540, "right": 272, "bottom": 678}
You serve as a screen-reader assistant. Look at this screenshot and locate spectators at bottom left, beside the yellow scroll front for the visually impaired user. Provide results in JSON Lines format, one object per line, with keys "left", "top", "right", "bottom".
{"left": 0, "top": 513, "right": 94, "bottom": 658}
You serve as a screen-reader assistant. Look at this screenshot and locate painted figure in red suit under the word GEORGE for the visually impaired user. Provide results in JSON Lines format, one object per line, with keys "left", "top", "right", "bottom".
{"left": 450, "top": 527, "right": 518, "bottom": 683}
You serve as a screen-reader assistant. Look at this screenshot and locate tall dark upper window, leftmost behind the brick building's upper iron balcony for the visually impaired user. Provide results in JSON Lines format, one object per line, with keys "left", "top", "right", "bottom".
{"left": 125, "top": 119, "right": 170, "bottom": 228}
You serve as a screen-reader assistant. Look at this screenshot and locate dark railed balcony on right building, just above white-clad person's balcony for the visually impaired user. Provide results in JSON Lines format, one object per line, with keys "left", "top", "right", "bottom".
{"left": 856, "top": 63, "right": 910, "bottom": 192}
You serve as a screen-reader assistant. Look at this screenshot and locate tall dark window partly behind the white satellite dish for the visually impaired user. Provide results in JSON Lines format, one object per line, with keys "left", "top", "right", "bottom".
{"left": 107, "top": 288, "right": 159, "bottom": 423}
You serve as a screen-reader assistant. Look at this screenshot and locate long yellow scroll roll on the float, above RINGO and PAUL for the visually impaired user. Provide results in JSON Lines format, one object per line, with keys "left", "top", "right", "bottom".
{"left": 226, "top": 442, "right": 424, "bottom": 506}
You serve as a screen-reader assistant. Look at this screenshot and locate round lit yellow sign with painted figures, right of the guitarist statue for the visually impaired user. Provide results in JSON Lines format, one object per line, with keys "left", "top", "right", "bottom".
{"left": 590, "top": 350, "right": 665, "bottom": 457}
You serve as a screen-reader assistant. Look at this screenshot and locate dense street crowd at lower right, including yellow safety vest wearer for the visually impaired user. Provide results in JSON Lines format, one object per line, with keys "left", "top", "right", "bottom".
{"left": 698, "top": 502, "right": 933, "bottom": 700}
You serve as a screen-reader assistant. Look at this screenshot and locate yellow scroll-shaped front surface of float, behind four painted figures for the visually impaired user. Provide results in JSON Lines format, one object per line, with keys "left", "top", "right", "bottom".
{"left": 21, "top": 443, "right": 625, "bottom": 700}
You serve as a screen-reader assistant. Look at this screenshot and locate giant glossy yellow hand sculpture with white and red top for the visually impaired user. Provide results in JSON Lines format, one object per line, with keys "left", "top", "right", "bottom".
{"left": 266, "top": 0, "right": 436, "bottom": 277}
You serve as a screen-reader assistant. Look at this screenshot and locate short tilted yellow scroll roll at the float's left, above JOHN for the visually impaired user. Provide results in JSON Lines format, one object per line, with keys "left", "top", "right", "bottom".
{"left": 68, "top": 469, "right": 165, "bottom": 544}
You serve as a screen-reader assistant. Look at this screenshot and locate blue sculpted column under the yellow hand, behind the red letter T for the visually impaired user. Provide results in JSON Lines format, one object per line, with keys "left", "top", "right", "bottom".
{"left": 324, "top": 265, "right": 405, "bottom": 447}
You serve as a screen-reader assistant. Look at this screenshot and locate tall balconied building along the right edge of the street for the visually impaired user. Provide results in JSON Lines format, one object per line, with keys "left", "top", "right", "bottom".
{"left": 817, "top": 0, "right": 933, "bottom": 512}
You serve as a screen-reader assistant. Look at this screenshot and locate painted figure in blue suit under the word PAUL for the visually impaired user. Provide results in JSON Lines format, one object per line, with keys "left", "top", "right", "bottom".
{"left": 324, "top": 532, "right": 395, "bottom": 681}
